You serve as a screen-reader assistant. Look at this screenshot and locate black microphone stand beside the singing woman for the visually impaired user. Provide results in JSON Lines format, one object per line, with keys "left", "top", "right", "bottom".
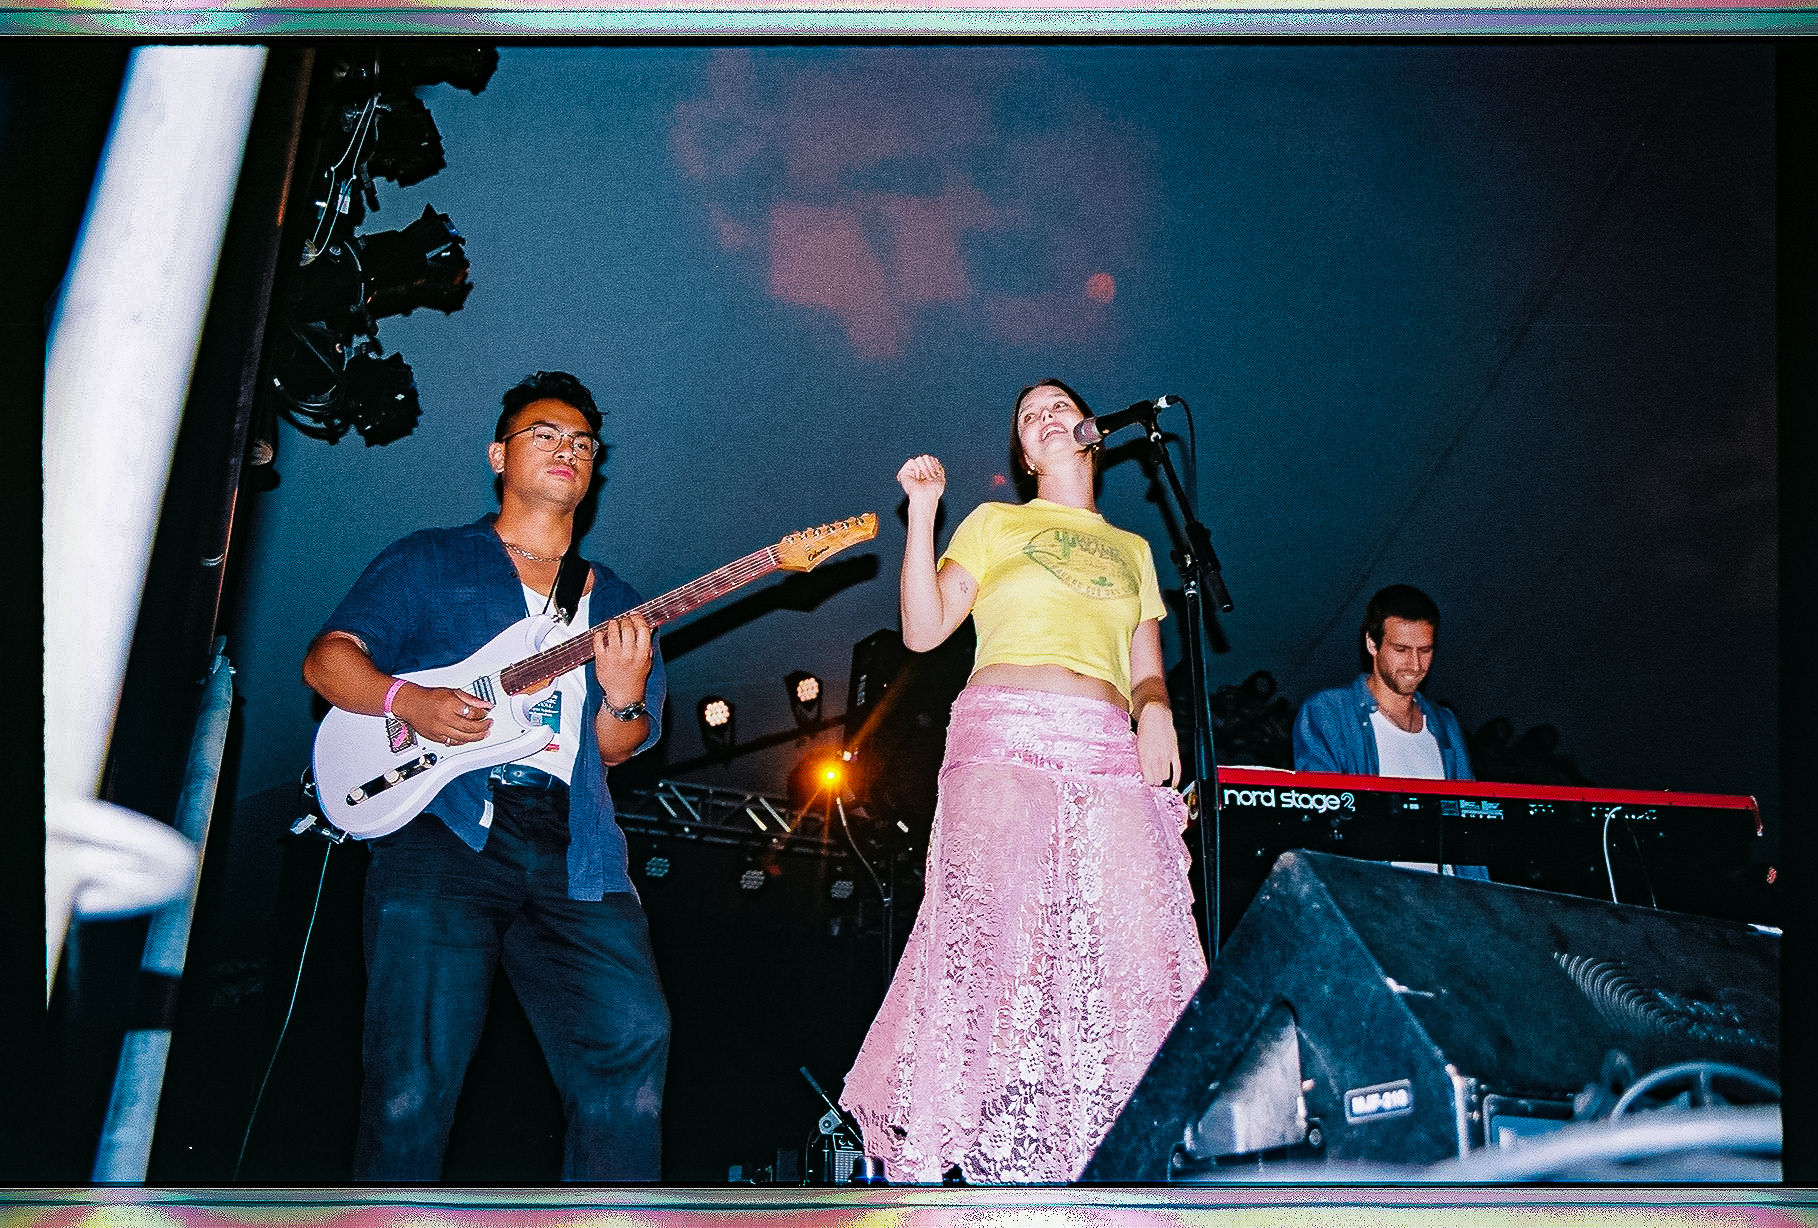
{"left": 1142, "top": 397, "right": 1231, "bottom": 961}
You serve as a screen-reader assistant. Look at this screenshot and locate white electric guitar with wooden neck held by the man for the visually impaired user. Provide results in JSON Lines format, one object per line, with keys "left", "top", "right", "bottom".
{"left": 313, "top": 511, "right": 878, "bottom": 840}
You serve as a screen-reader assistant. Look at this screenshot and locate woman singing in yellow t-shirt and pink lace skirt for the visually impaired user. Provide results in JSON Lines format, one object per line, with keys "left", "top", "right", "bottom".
{"left": 842, "top": 380, "right": 1205, "bottom": 1183}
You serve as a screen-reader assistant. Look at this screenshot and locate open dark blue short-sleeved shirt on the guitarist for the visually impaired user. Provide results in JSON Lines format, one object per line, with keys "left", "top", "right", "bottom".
{"left": 322, "top": 513, "right": 667, "bottom": 901}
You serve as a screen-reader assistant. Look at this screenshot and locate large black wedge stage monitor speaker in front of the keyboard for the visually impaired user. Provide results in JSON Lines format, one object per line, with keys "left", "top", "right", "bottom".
{"left": 1082, "top": 851, "right": 1780, "bottom": 1183}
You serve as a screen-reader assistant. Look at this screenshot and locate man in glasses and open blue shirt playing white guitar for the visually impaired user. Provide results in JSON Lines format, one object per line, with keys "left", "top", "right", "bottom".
{"left": 304, "top": 371, "right": 669, "bottom": 1183}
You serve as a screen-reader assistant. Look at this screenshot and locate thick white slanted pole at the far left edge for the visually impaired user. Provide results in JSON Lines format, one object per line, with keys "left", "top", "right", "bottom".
{"left": 44, "top": 45, "right": 265, "bottom": 993}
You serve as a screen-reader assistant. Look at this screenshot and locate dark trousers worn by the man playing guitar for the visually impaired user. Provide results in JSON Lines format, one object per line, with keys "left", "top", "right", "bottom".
{"left": 355, "top": 786, "right": 669, "bottom": 1181}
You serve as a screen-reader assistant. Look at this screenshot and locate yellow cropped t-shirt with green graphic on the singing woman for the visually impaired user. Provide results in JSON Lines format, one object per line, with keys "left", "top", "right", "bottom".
{"left": 940, "top": 498, "right": 1167, "bottom": 699}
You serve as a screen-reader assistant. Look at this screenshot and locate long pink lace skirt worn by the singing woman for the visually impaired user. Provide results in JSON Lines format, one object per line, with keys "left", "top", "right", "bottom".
{"left": 840, "top": 686, "right": 1205, "bottom": 1183}
